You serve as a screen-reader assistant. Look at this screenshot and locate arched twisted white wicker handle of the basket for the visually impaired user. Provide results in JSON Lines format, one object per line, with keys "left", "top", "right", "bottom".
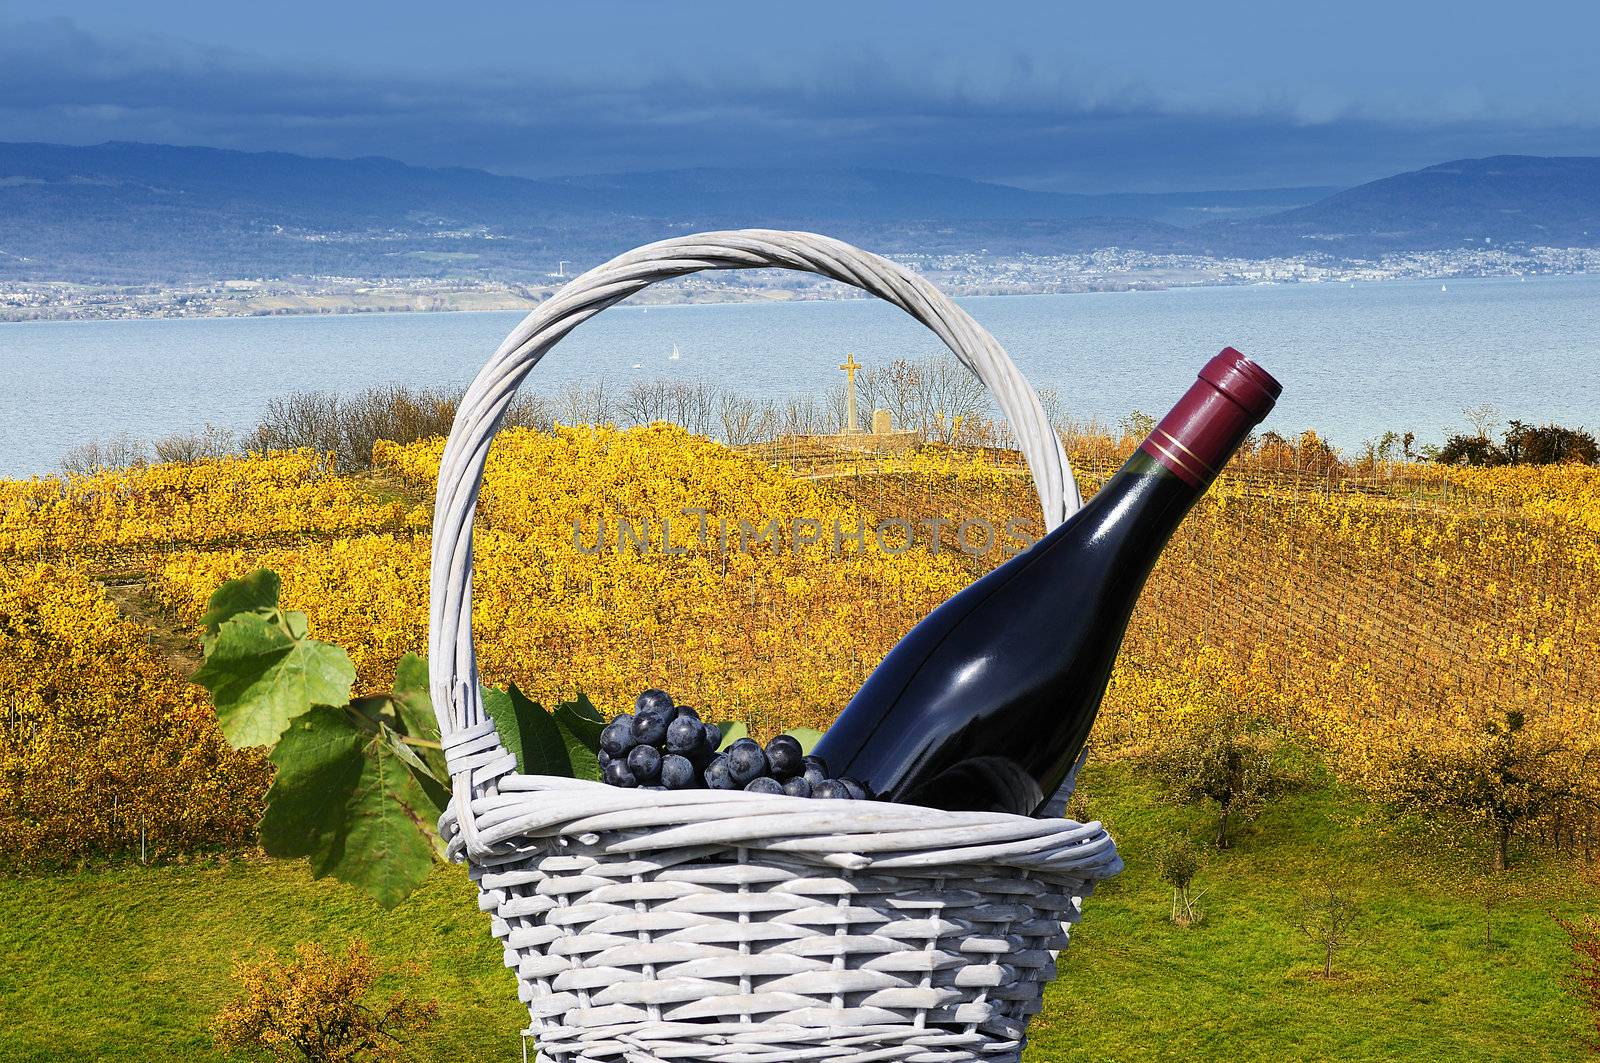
{"left": 429, "top": 229, "right": 1080, "bottom": 746}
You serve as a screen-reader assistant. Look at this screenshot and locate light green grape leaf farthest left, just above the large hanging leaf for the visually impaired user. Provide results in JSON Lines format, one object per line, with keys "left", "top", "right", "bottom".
{"left": 194, "top": 605, "right": 355, "bottom": 748}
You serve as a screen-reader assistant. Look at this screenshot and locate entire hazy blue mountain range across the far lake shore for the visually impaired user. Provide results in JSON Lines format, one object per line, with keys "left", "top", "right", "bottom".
{"left": 0, "top": 142, "right": 1600, "bottom": 283}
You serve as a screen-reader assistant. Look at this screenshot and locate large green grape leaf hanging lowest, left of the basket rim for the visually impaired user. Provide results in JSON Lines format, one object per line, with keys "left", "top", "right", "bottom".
{"left": 261, "top": 706, "right": 437, "bottom": 908}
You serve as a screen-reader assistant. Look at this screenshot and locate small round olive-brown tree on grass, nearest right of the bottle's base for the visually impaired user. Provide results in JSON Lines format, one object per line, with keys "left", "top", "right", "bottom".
{"left": 1152, "top": 709, "right": 1288, "bottom": 848}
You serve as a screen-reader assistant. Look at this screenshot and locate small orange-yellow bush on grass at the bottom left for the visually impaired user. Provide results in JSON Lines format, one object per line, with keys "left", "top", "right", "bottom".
{"left": 211, "top": 941, "right": 438, "bottom": 1063}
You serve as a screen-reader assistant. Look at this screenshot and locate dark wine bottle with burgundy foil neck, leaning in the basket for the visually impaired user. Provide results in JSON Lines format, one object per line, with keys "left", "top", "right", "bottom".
{"left": 816, "top": 347, "right": 1282, "bottom": 815}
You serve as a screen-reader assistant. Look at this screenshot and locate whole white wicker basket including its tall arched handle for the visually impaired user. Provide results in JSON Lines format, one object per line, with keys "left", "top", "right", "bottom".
{"left": 429, "top": 231, "right": 1122, "bottom": 1063}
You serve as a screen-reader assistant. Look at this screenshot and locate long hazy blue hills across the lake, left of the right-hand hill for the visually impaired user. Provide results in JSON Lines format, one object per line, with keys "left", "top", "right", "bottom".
{"left": 0, "top": 142, "right": 1320, "bottom": 282}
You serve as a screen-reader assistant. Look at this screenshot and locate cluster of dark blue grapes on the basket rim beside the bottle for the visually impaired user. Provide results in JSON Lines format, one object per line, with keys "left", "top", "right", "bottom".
{"left": 600, "top": 690, "right": 867, "bottom": 800}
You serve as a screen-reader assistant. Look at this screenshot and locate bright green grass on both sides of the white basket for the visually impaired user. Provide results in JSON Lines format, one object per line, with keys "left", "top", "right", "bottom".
{"left": 0, "top": 767, "right": 1600, "bottom": 1063}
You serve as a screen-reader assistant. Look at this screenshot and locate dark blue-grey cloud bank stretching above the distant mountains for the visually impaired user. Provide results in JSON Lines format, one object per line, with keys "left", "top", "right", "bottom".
{"left": 0, "top": 19, "right": 1600, "bottom": 191}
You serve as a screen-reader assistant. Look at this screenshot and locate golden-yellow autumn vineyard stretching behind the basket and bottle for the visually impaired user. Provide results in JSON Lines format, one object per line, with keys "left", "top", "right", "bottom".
{"left": 0, "top": 424, "right": 1600, "bottom": 848}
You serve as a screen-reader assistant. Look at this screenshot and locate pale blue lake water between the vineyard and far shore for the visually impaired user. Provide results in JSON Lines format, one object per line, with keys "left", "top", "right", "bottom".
{"left": 0, "top": 275, "right": 1600, "bottom": 477}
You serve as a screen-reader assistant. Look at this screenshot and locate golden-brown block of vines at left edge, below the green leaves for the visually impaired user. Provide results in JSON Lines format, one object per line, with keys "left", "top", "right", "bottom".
{"left": 0, "top": 565, "right": 267, "bottom": 864}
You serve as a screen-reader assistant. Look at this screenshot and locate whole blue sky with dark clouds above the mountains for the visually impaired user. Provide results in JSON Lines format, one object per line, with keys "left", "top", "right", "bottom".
{"left": 0, "top": 0, "right": 1600, "bottom": 192}
